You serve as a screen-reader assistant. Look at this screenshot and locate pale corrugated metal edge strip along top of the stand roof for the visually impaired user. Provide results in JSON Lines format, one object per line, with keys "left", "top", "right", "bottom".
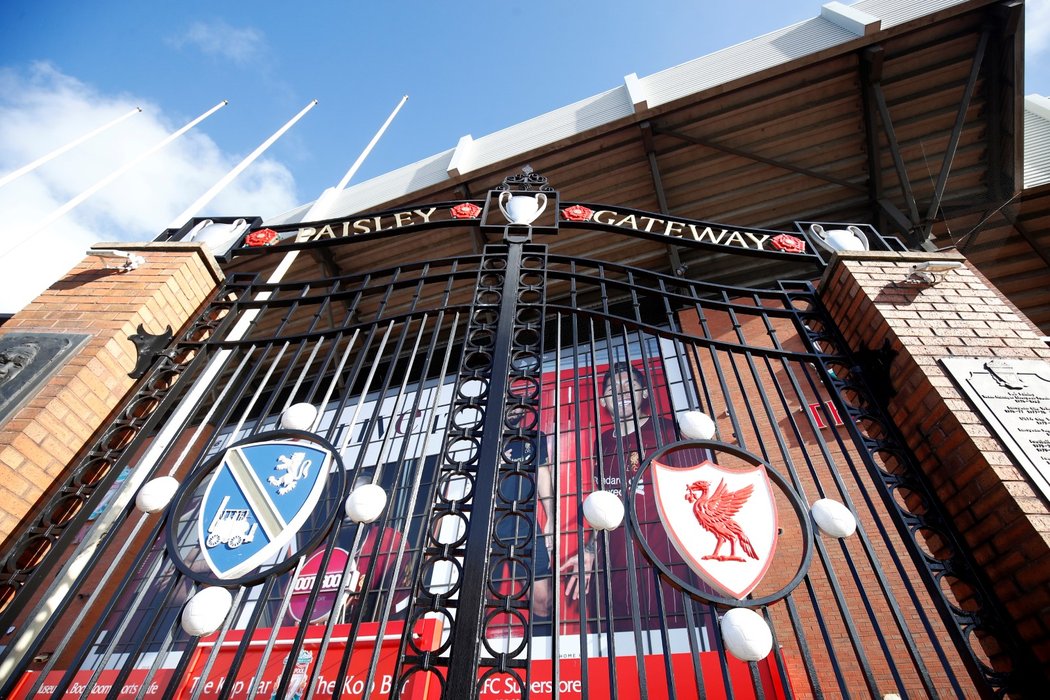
{"left": 267, "top": 0, "right": 990, "bottom": 226}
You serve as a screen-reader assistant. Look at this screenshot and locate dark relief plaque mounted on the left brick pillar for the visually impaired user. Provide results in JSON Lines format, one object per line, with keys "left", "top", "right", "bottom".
{"left": 0, "top": 333, "right": 90, "bottom": 425}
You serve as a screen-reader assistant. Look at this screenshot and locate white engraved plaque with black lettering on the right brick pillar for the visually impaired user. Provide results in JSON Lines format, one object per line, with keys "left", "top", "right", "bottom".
{"left": 941, "top": 358, "right": 1050, "bottom": 500}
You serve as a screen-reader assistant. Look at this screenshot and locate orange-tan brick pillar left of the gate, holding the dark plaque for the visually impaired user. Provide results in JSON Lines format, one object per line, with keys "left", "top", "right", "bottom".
{"left": 0, "top": 242, "right": 222, "bottom": 542}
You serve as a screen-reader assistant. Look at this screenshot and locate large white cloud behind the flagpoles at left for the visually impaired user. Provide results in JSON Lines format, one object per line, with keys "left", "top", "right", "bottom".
{"left": 0, "top": 64, "right": 298, "bottom": 313}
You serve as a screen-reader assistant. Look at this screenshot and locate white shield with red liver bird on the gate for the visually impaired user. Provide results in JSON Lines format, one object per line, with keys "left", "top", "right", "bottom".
{"left": 652, "top": 460, "right": 777, "bottom": 599}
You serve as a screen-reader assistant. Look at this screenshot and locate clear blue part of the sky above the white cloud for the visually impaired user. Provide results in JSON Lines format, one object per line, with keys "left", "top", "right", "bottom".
{"left": 0, "top": 0, "right": 852, "bottom": 200}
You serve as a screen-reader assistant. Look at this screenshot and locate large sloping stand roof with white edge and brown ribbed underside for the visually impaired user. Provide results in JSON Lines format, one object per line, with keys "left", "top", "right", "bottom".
{"left": 231, "top": 0, "right": 1050, "bottom": 328}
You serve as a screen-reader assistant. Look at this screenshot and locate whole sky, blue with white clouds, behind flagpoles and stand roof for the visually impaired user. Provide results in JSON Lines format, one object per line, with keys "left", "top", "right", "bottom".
{"left": 0, "top": 0, "right": 1050, "bottom": 313}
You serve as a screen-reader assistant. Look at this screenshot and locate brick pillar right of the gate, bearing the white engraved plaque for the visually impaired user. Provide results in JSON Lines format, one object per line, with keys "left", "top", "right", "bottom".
{"left": 820, "top": 252, "right": 1050, "bottom": 671}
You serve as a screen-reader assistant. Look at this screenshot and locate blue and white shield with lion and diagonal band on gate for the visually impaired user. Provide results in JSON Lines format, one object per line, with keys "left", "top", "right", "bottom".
{"left": 197, "top": 440, "right": 332, "bottom": 578}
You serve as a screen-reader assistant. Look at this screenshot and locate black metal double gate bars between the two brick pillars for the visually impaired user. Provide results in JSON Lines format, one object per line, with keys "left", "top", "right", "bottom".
{"left": 2, "top": 201, "right": 1016, "bottom": 700}
